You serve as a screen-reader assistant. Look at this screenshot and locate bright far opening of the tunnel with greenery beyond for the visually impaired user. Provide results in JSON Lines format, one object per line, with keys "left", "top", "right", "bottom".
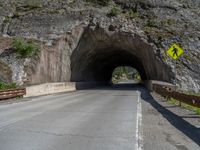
{"left": 111, "top": 66, "right": 141, "bottom": 84}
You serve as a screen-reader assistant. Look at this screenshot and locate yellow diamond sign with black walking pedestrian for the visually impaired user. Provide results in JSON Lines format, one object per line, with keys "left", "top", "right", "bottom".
{"left": 167, "top": 44, "right": 184, "bottom": 60}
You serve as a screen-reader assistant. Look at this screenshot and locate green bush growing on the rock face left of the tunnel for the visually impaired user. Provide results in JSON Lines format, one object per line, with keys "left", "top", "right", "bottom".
{"left": 12, "top": 38, "right": 39, "bottom": 58}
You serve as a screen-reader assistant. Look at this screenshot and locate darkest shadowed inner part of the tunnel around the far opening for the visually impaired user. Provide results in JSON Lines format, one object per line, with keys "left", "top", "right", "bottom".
{"left": 71, "top": 48, "right": 148, "bottom": 82}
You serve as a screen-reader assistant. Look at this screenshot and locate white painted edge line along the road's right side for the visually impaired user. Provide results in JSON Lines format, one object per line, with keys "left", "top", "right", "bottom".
{"left": 135, "top": 91, "right": 142, "bottom": 150}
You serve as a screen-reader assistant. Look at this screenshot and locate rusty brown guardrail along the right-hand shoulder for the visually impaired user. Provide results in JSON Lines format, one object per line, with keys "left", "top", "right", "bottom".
{"left": 153, "top": 84, "right": 200, "bottom": 108}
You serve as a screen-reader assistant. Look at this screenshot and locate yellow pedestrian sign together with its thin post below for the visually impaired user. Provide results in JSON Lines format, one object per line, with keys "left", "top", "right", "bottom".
{"left": 167, "top": 44, "right": 184, "bottom": 106}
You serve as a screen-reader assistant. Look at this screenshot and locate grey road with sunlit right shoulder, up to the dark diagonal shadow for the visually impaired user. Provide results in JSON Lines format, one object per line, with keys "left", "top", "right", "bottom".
{"left": 0, "top": 86, "right": 199, "bottom": 150}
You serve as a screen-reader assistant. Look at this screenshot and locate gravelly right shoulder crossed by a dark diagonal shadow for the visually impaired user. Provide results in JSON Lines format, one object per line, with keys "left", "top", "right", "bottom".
{"left": 141, "top": 89, "right": 200, "bottom": 150}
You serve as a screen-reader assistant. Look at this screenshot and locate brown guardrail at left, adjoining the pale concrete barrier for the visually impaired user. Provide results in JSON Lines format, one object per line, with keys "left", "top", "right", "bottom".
{"left": 0, "top": 88, "right": 26, "bottom": 100}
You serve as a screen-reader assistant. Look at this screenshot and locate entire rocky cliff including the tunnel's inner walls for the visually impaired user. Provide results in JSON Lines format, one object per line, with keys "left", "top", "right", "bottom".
{"left": 0, "top": 0, "right": 200, "bottom": 92}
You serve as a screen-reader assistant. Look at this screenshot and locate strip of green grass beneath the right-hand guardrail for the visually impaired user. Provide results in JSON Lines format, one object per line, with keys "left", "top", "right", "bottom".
{"left": 169, "top": 98, "right": 200, "bottom": 115}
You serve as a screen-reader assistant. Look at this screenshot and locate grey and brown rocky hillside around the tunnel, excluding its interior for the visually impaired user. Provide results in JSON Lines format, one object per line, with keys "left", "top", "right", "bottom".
{"left": 0, "top": 0, "right": 200, "bottom": 92}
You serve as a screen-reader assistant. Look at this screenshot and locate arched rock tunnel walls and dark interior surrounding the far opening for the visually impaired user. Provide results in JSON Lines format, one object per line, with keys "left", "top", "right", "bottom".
{"left": 71, "top": 27, "right": 172, "bottom": 82}
